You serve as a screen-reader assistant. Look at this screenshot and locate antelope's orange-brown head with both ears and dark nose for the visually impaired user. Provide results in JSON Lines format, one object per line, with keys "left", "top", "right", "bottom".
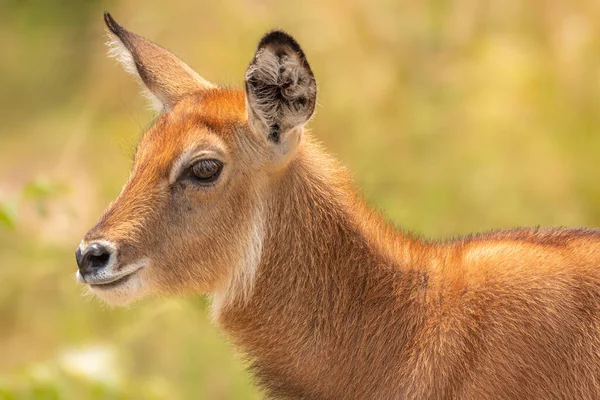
{"left": 76, "top": 13, "right": 317, "bottom": 304}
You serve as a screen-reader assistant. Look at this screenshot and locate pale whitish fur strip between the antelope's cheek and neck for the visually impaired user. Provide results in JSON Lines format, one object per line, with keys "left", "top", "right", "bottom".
{"left": 210, "top": 205, "right": 265, "bottom": 322}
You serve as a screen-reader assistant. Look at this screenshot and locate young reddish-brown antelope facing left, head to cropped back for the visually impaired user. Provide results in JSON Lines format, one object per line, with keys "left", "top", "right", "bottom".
{"left": 76, "top": 13, "right": 600, "bottom": 399}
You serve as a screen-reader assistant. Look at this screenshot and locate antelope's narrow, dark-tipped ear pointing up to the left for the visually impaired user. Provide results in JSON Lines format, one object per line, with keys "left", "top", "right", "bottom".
{"left": 104, "top": 13, "right": 214, "bottom": 112}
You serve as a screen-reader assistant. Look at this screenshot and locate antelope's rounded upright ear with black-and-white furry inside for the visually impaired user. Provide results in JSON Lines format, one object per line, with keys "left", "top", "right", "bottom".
{"left": 245, "top": 31, "right": 317, "bottom": 153}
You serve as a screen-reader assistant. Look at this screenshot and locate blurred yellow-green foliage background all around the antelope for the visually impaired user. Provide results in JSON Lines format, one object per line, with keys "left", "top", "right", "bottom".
{"left": 0, "top": 0, "right": 600, "bottom": 399}
